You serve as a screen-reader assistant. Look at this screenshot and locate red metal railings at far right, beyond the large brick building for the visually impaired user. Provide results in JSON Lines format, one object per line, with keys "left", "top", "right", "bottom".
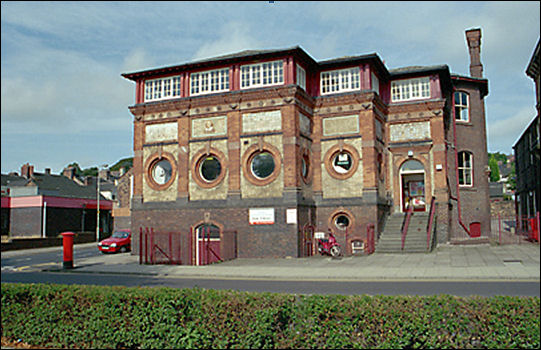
{"left": 490, "top": 212, "right": 539, "bottom": 244}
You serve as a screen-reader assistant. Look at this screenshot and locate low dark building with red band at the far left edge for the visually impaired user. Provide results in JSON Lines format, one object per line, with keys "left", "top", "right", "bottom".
{"left": 2, "top": 164, "right": 113, "bottom": 238}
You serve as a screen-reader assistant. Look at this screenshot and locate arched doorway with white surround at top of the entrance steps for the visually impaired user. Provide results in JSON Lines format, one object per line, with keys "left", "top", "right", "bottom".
{"left": 400, "top": 159, "right": 426, "bottom": 212}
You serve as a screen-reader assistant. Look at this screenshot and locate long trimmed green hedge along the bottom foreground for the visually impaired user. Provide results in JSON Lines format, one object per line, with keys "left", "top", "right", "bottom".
{"left": 2, "top": 283, "right": 540, "bottom": 349}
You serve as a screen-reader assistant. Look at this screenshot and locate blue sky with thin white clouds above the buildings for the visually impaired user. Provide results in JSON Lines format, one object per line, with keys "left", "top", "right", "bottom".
{"left": 1, "top": 1, "right": 540, "bottom": 174}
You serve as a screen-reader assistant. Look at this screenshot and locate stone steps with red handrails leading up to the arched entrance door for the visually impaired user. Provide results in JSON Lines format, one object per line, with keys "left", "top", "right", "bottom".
{"left": 376, "top": 212, "right": 430, "bottom": 253}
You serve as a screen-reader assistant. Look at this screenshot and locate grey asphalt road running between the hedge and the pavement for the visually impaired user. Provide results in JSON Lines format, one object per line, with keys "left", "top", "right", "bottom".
{"left": 1, "top": 246, "right": 540, "bottom": 296}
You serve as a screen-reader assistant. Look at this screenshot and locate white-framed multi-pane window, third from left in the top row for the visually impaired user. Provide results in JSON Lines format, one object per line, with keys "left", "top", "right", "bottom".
{"left": 240, "top": 60, "right": 284, "bottom": 89}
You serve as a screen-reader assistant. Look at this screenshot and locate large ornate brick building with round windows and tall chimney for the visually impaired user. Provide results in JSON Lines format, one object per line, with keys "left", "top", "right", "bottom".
{"left": 122, "top": 29, "right": 490, "bottom": 263}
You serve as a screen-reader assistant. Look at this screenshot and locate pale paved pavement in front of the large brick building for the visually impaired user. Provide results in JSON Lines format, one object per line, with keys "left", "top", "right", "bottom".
{"left": 2, "top": 243, "right": 540, "bottom": 281}
